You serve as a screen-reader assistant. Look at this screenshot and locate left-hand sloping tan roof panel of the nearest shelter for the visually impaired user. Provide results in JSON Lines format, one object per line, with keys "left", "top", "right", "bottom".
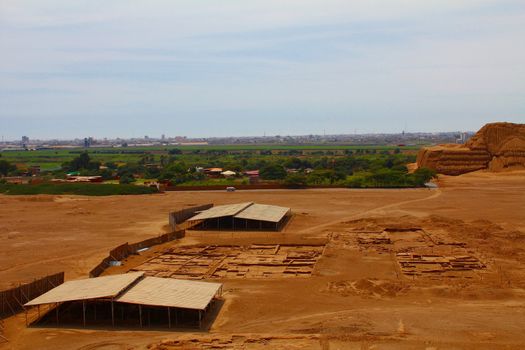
{"left": 25, "top": 272, "right": 144, "bottom": 306}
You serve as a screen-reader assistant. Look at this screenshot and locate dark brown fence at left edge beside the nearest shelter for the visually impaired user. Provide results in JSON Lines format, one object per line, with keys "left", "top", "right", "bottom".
{"left": 0, "top": 272, "right": 64, "bottom": 318}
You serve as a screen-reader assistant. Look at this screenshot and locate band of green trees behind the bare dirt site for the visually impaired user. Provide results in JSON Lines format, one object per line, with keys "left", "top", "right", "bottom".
{"left": 4, "top": 152, "right": 435, "bottom": 187}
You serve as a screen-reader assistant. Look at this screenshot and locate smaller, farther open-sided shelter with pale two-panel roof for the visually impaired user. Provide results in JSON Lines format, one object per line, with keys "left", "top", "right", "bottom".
{"left": 188, "top": 202, "right": 291, "bottom": 231}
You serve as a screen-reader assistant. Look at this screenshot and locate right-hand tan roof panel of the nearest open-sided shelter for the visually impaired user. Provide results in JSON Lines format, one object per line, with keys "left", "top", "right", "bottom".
{"left": 116, "top": 277, "right": 222, "bottom": 310}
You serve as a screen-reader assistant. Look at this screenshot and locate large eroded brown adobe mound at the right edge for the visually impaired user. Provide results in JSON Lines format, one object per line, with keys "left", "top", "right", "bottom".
{"left": 417, "top": 123, "right": 525, "bottom": 175}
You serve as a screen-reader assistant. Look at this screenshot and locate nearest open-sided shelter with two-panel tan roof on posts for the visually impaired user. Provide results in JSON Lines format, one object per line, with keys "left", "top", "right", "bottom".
{"left": 25, "top": 272, "right": 222, "bottom": 328}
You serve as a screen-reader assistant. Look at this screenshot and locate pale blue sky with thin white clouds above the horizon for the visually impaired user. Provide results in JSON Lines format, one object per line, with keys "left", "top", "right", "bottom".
{"left": 0, "top": 0, "right": 525, "bottom": 139}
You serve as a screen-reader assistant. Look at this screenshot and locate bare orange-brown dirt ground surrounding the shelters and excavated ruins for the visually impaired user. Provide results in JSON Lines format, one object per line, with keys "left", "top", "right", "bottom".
{"left": 0, "top": 171, "right": 525, "bottom": 350}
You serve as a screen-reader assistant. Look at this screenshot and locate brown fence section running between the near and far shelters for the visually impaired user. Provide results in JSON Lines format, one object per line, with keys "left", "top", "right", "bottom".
{"left": 89, "top": 230, "right": 186, "bottom": 277}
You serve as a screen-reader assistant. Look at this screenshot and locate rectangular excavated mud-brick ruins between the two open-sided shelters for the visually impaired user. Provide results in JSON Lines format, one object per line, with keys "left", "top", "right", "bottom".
{"left": 133, "top": 244, "right": 325, "bottom": 279}
